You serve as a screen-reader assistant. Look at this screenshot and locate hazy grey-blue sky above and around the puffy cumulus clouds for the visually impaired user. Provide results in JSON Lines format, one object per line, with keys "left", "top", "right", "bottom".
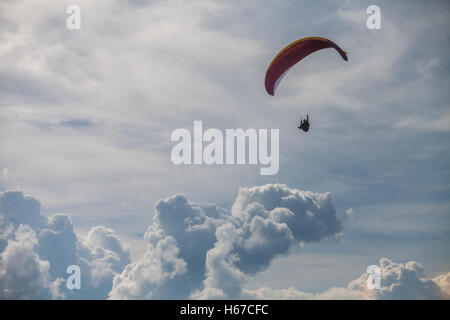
{"left": 0, "top": 0, "right": 450, "bottom": 300}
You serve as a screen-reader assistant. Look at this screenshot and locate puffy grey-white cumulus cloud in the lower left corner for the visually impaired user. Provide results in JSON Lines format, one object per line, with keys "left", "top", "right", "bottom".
{"left": 0, "top": 191, "right": 130, "bottom": 299}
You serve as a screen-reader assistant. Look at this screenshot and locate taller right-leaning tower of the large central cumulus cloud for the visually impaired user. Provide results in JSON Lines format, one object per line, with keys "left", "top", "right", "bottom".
{"left": 193, "top": 184, "right": 341, "bottom": 299}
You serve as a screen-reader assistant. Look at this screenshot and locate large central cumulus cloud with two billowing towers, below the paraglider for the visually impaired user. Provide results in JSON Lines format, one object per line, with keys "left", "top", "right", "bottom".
{"left": 110, "top": 184, "right": 341, "bottom": 299}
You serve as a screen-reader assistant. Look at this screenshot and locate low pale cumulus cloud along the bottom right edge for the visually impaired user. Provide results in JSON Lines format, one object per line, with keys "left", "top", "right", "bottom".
{"left": 243, "top": 258, "right": 449, "bottom": 300}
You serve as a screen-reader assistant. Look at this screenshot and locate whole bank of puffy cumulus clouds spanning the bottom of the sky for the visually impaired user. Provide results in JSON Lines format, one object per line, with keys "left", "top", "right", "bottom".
{"left": 0, "top": 188, "right": 450, "bottom": 299}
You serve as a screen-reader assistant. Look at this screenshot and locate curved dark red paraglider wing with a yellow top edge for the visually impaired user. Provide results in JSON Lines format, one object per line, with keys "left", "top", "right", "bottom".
{"left": 264, "top": 37, "right": 348, "bottom": 96}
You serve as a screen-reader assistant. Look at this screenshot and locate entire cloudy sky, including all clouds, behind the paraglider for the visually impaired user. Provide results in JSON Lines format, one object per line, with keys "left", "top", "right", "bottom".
{"left": 0, "top": 0, "right": 450, "bottom": 299}
